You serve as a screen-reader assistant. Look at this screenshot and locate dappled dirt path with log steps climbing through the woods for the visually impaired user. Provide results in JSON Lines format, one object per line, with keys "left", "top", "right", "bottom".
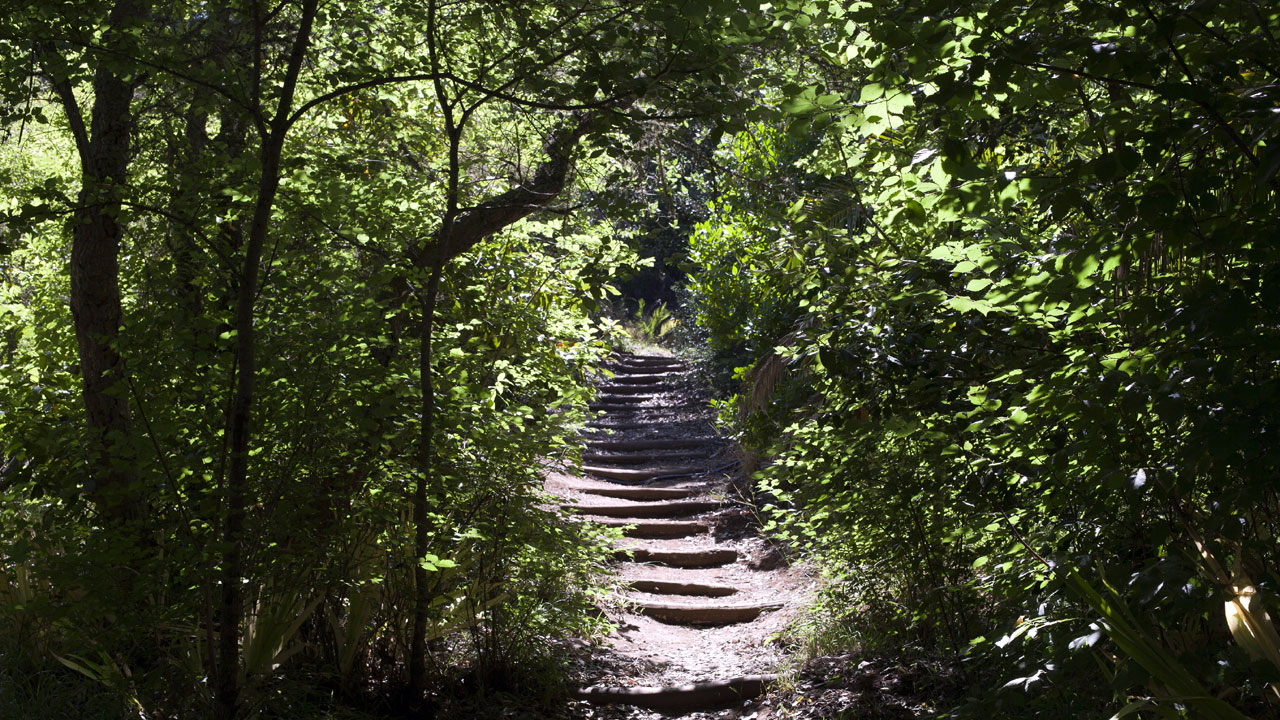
{"left": 547, "top": 355, "right": 810, "bottom": 720}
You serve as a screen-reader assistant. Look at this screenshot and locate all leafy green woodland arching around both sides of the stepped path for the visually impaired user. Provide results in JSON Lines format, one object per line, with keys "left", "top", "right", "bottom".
{"left": 0, "top": 0, "right": 1280, "bottom": 719}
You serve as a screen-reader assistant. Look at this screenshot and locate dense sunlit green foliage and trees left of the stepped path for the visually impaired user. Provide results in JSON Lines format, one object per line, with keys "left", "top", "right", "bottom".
{"left": 0, "top": 0, "right": 752, "bottom": 719}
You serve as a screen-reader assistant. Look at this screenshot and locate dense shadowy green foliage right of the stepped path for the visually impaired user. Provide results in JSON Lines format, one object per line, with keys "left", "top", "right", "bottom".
{"left": 689, "top": 0, "right": 1280, "bottom": 717}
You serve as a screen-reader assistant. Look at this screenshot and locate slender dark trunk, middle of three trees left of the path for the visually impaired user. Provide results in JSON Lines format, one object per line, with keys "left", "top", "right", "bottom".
{"left": 214, "top": 0, "right": 319, "bottom": 720}
